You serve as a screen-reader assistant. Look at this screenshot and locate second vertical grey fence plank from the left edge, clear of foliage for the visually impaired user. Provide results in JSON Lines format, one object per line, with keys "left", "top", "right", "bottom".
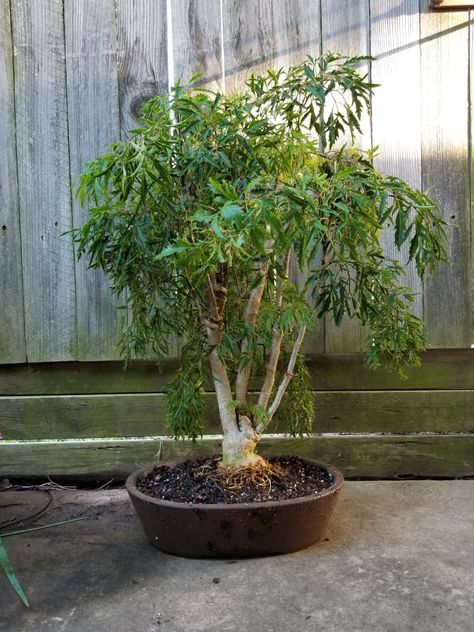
{"left": 12, "top": 0, "right": 77, "bottom": 362}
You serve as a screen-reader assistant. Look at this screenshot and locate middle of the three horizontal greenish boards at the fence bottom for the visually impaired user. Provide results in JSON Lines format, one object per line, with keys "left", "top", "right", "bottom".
{"left": 0, "top": 390, "right": 474, "bottom": 440}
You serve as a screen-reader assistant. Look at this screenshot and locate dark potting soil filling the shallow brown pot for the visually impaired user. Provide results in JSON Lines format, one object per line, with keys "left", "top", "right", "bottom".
{"left": 137, "top": 456, "right": 333, "bottom": 504}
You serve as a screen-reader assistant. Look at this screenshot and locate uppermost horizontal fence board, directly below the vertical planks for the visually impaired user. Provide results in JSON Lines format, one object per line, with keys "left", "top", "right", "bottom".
{"left": 0, "top": 349, "right": 474, "bottom": 396}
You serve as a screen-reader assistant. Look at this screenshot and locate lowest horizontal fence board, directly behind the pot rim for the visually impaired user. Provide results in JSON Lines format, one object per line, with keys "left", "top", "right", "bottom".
{"left": 0, "top": 434, "right": 474, "bottom": 480}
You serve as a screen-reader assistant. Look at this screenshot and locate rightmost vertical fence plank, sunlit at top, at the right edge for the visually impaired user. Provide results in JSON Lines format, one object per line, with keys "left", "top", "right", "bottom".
{"left": 420, "top": 0, "right": 472, "bottom": 348}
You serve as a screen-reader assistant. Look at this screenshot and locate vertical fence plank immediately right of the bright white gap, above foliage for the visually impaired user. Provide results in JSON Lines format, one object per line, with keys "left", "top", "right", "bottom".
{"left": 171, "top": 0, "right": 224, "bottom": 90}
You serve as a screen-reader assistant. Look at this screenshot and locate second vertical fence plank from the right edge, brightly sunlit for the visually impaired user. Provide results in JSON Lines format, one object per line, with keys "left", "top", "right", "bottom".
{"left": 371, "top": 0, "right": 423, "bottom": 317}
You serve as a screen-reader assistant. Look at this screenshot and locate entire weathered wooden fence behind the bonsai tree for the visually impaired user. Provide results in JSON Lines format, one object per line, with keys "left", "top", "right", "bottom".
{"left": 0, "top": 0, "right": 474, "bottom": 478}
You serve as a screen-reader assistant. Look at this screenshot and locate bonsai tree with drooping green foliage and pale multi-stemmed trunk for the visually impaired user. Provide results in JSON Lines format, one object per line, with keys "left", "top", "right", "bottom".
{"left": 75, "top": 54, "right": 445, "bottom": 467}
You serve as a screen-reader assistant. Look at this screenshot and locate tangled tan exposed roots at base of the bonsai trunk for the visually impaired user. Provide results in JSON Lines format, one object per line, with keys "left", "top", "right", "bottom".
{"left": 199, "top": 460, "right": 287, "bottom": 493}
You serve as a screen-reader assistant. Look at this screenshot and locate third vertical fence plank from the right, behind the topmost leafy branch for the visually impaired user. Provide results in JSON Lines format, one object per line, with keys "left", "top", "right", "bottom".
{"left": 321, "top": 0, "right": 371, "bottom": 353}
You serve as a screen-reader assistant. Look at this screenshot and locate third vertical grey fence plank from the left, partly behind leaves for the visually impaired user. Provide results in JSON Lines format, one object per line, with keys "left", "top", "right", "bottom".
{"left": 64, "top": 0, "right": 120, "bottom": 360}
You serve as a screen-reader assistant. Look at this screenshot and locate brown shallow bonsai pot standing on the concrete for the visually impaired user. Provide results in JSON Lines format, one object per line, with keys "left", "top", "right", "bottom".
{"left": 126, "top": 459, "right": 344, "bottom": 557}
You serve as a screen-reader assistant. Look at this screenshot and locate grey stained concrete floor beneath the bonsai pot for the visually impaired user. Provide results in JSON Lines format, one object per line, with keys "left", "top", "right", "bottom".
{"left": 0, "top": 481, "right": 474, "bottom": 632}
